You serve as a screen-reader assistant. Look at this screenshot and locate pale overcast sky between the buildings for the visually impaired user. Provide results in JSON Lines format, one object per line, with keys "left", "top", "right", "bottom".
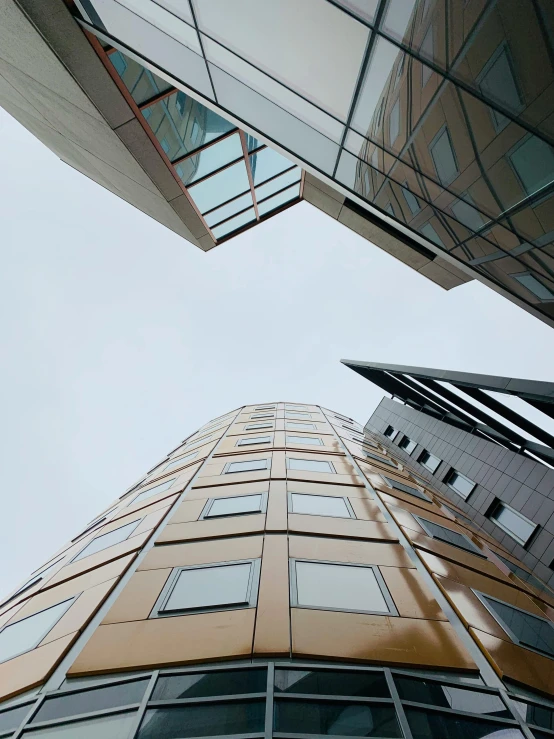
{"left": 0, "top": 109, "right": 554, "bottom": 596}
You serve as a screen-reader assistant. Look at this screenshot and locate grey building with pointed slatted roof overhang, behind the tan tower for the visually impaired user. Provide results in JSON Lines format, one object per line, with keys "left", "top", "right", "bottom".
{"left": 343, "top": 360, "right": 554, "bottom": 592}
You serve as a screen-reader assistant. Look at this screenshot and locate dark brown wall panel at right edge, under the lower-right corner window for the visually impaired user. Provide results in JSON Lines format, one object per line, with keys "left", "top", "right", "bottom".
{"left": 470, "top": 629, "right": 554, "bottom": 696}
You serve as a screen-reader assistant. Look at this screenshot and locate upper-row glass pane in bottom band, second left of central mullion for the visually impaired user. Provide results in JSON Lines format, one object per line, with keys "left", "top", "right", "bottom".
{"left": 33, "top": 680, "right": 148, "bottom": 723}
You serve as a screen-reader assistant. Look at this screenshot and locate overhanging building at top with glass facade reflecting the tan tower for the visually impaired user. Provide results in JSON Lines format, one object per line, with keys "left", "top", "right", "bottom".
{"left": 0, "top": 0, "right": 554, "bottom": 326}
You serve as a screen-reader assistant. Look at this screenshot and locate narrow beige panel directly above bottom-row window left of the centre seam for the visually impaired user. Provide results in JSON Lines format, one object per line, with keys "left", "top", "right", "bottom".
{"left": 138, "top": 536, "right": 263, "bottom": 572}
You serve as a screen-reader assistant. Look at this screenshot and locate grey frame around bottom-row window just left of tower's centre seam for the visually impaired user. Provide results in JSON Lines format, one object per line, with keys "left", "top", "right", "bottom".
{"left": 148, "top": 557, "right": 261, "bottom": 619}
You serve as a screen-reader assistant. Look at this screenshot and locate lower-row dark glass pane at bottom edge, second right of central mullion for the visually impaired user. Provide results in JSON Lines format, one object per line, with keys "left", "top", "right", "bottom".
{"left": 406, "top": 707, "right": 524, "bottom": 739}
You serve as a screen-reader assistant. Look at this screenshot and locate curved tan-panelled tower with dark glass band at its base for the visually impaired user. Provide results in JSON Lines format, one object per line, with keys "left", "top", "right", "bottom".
{"left": 0, "top": 402, "right": 554, "bottom": 739}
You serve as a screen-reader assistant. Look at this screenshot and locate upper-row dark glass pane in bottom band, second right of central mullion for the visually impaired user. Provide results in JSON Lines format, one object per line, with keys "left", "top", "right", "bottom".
{"left": 394, "top": 675, "right": 506, "bottom": 718}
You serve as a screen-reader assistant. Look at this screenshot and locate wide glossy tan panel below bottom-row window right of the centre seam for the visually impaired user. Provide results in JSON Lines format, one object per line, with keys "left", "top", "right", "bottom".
{"left": 292, "top": 608, "right": 476, "bottom": 670}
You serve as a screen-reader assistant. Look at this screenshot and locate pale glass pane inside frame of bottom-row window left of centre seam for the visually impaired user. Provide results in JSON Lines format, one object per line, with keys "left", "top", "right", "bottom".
{"left": 161, "top": 562, "right": 252, "bottom": 613}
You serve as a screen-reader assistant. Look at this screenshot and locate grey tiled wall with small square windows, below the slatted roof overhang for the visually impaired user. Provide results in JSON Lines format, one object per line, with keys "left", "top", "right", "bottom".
{"left": 366, "top": 397, "right": 554, "bottom": 588}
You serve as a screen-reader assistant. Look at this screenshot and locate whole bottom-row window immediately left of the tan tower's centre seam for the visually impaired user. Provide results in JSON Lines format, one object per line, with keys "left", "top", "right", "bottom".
{"left": 153, "top": 560, "right": 259, "bottom": 616}
